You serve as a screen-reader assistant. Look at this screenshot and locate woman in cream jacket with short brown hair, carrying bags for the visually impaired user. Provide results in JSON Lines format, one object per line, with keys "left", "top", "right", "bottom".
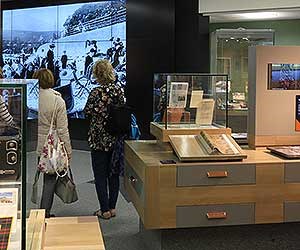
{"left": 33, "top": 69, "right": 72, "bottom": 218}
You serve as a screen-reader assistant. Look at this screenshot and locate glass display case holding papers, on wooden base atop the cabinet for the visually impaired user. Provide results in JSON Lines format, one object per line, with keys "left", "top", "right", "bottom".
{"left": 150, "top": 73, "right": 230, "bottom": 141}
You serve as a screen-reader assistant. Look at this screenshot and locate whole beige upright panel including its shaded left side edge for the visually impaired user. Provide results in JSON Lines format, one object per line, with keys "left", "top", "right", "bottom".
{"left": 249, "top": 46, "right": 300, "bottom": 146}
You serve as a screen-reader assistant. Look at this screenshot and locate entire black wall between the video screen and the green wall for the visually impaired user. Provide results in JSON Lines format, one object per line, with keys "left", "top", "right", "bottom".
{"left": 127, "top": 0, "right": 209, "bottom": 138}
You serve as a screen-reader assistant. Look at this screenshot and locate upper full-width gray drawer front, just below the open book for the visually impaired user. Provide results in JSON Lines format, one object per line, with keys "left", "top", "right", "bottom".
{"left": 177, "top": 164, "right": 256, "bottom": 187}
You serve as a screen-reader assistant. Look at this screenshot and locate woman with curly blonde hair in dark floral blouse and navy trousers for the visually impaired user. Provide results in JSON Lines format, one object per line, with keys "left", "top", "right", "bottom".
{"left": 84, "top": 60, "right": 125, "bottom": 219}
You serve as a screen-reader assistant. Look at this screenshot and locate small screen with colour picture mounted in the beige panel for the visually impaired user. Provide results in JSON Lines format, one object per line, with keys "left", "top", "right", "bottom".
{"left": 268, "top": 63, "right": 300, "bottom": 90}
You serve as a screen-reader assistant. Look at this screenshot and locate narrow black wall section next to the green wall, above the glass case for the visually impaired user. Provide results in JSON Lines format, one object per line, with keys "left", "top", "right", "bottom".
{"left": 175, "top": 0, "right": 210, "bottom": 73}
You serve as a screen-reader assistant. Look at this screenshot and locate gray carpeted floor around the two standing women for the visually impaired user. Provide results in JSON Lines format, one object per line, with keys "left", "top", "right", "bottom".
{"left": 27, "top": 150, "right": 144, "bottom": 250}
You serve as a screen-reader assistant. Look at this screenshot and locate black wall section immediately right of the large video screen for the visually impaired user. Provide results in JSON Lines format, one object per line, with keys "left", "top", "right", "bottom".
{"left": 126, "top": 0, "right": 175, "bottom": 138}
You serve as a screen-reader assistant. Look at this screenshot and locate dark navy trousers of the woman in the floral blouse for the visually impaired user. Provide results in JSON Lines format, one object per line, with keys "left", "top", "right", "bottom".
{"left": 91, "top": 150, "right": 120, "bottom": 212}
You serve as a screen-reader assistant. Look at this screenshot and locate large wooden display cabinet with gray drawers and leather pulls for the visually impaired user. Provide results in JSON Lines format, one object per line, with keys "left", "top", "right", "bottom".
{"left": 125, "top": 141, "right": 300, "bottom": 229}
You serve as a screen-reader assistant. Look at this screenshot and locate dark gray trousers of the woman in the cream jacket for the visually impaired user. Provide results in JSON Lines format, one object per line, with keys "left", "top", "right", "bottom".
{"left": 40, "top": 174, "right": 57, "bottom": 217}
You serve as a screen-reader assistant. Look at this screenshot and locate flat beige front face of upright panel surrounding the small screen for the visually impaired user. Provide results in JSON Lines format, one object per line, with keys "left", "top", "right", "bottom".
{"left": 256, "top": 46, "right": 300, "bottom": 135}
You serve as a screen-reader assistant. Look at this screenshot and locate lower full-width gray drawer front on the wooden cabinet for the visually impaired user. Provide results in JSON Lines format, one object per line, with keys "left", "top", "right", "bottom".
{"left": 176, "top": 203, "right": 255, "bottom": 227}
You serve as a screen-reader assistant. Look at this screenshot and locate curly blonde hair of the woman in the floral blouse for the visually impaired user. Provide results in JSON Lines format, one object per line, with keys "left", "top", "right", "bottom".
{"left": 93, "top": 60, "right": 116, "bottom": 84}
